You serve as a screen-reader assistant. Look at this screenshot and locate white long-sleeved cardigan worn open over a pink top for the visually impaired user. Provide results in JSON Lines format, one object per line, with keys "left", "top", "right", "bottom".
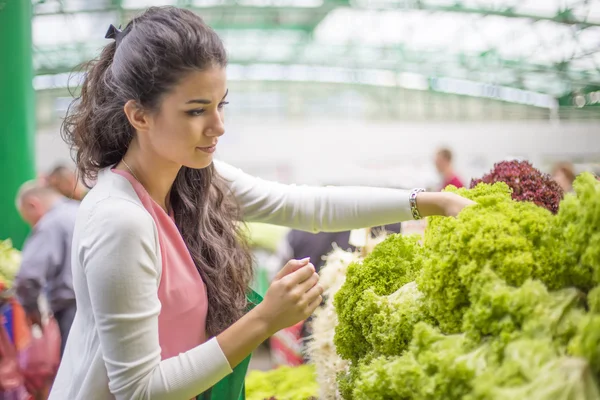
{"left": 50, "top": 161, "right": 412, "bottom": 400}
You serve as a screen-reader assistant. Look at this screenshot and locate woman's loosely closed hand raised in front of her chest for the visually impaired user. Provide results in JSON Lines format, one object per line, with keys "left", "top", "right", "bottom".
{"left": 256, "top": 259, "right": 323, "bottom": 334}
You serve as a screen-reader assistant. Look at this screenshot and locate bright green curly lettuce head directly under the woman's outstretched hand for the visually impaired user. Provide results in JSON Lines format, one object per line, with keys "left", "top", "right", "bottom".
{"left": 417, "top": 182, "right": 565, "bottom": 333}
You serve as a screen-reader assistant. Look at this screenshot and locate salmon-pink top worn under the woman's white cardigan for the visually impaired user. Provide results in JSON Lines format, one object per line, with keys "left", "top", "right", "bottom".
{"left": 113, "top": 169, "right": 208, "bottom": 360}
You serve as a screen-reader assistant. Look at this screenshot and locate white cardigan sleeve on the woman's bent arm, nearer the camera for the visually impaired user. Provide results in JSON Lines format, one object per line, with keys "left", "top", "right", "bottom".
{"left": 83, "top": 198, "right": 232, "bottom": 400}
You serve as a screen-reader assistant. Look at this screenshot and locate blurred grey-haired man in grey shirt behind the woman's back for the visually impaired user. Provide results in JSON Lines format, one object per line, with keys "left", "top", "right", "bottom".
{"left": 15, "top": 181, "right": 79, "bottom": 355}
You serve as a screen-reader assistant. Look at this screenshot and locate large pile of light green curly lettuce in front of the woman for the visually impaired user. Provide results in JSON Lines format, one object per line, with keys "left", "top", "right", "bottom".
{"left": 334, "top": 174, "right": 600, "bottom": 400}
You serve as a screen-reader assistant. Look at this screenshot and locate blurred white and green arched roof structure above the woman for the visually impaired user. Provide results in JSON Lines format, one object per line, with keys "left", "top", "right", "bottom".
{"left": 33, "top": 0, "right": 600, "bottom": 108}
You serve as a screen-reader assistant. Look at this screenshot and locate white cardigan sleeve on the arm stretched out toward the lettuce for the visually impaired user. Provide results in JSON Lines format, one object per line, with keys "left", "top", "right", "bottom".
{"left": 214, "top": 160, "right": 412, "bottom": 233}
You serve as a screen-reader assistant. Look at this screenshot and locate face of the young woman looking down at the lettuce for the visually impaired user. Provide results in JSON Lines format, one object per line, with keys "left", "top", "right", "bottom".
{"left": 138, "top": 67, "right": 227, "bottom": 169}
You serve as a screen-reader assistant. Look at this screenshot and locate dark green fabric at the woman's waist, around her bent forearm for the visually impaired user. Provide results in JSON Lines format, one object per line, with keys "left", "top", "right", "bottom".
{"left": 196, "top": 290, "right": 262, "bottom": 400}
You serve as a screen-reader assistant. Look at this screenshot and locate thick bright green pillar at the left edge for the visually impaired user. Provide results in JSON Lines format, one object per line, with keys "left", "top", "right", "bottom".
{"left": 0, "top": 0, "right": 35, "bottom": 248}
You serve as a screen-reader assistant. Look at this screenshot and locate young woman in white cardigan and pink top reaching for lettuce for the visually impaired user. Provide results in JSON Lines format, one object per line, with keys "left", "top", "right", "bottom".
{"left": 50, "top": 8, "right": 471, "bottom": 400}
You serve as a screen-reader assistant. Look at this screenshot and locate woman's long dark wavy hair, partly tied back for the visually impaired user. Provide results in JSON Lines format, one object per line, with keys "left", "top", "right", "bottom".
{"left": 62, "top": 7, "right": 252, "bottom": 336}
